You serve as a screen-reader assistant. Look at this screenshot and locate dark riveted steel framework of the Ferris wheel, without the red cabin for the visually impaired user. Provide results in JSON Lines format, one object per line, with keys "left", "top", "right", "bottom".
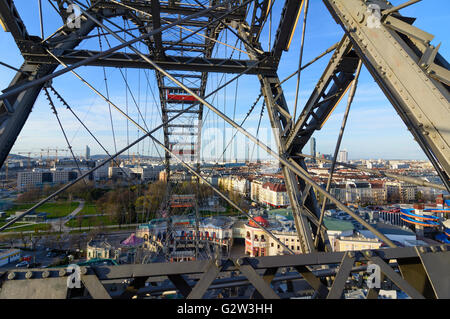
{"left": 0, "top": 0, "right": 450, "bottom": 298}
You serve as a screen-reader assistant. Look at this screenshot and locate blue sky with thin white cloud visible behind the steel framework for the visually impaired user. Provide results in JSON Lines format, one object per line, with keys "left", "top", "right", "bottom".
{"left": 0, "top": 0, "right": 450, "bottom": 159}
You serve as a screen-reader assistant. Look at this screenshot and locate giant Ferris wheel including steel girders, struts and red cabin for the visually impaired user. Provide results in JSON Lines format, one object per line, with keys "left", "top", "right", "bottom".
{"left": 0, "top": 0, "right": 450, "bottom": 298}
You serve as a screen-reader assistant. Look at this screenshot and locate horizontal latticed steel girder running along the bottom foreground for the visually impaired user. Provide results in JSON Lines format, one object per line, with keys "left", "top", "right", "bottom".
{"left": 0, "top": 245, "right": 450, "bottom": 299}
